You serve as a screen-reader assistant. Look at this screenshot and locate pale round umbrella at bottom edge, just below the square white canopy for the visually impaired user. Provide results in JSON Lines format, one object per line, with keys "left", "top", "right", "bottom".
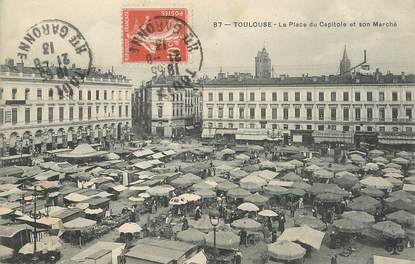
{"left": 268, "top": 240, "right": 306, "bottom": 261}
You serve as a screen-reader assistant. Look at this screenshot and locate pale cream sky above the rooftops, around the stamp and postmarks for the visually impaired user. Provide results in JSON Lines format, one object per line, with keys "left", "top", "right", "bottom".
{"left": 0, "top": 0, "right": 415, "bottom": 83}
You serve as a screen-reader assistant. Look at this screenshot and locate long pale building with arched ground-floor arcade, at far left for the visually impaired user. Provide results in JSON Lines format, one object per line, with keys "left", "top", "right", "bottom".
{"left": 0, "top": 61, "right": 133, "bottom": 155}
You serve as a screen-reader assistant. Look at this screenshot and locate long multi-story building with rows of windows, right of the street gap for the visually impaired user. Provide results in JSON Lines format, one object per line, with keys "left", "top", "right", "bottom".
{"left": 202, "top": 74, "right": 415, "bottom": 143}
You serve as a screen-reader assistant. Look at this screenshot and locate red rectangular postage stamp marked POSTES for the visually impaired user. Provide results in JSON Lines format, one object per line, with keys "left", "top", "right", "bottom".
{"left": 122, "top": 8, "right": 188, "bottom": 63}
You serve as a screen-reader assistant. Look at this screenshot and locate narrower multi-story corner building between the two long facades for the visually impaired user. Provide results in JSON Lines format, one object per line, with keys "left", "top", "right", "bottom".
{"left": 133, "top": 77, "right": 202, "bottom": 137}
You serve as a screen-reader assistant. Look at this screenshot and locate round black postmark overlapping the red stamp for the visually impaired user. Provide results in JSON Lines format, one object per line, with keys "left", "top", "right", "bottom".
{"left": 129, "top": 12, "right": 203, "bottom": 88}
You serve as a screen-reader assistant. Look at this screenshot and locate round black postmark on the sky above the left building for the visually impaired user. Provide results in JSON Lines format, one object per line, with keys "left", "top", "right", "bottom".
{"left": 17, "top": 19, "right": 93, "bottom": 96}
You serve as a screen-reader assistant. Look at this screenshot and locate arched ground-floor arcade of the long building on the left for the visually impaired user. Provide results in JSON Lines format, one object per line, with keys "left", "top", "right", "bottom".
{"left": 0, "top": 119, "right": 131, "bottom": 156}
